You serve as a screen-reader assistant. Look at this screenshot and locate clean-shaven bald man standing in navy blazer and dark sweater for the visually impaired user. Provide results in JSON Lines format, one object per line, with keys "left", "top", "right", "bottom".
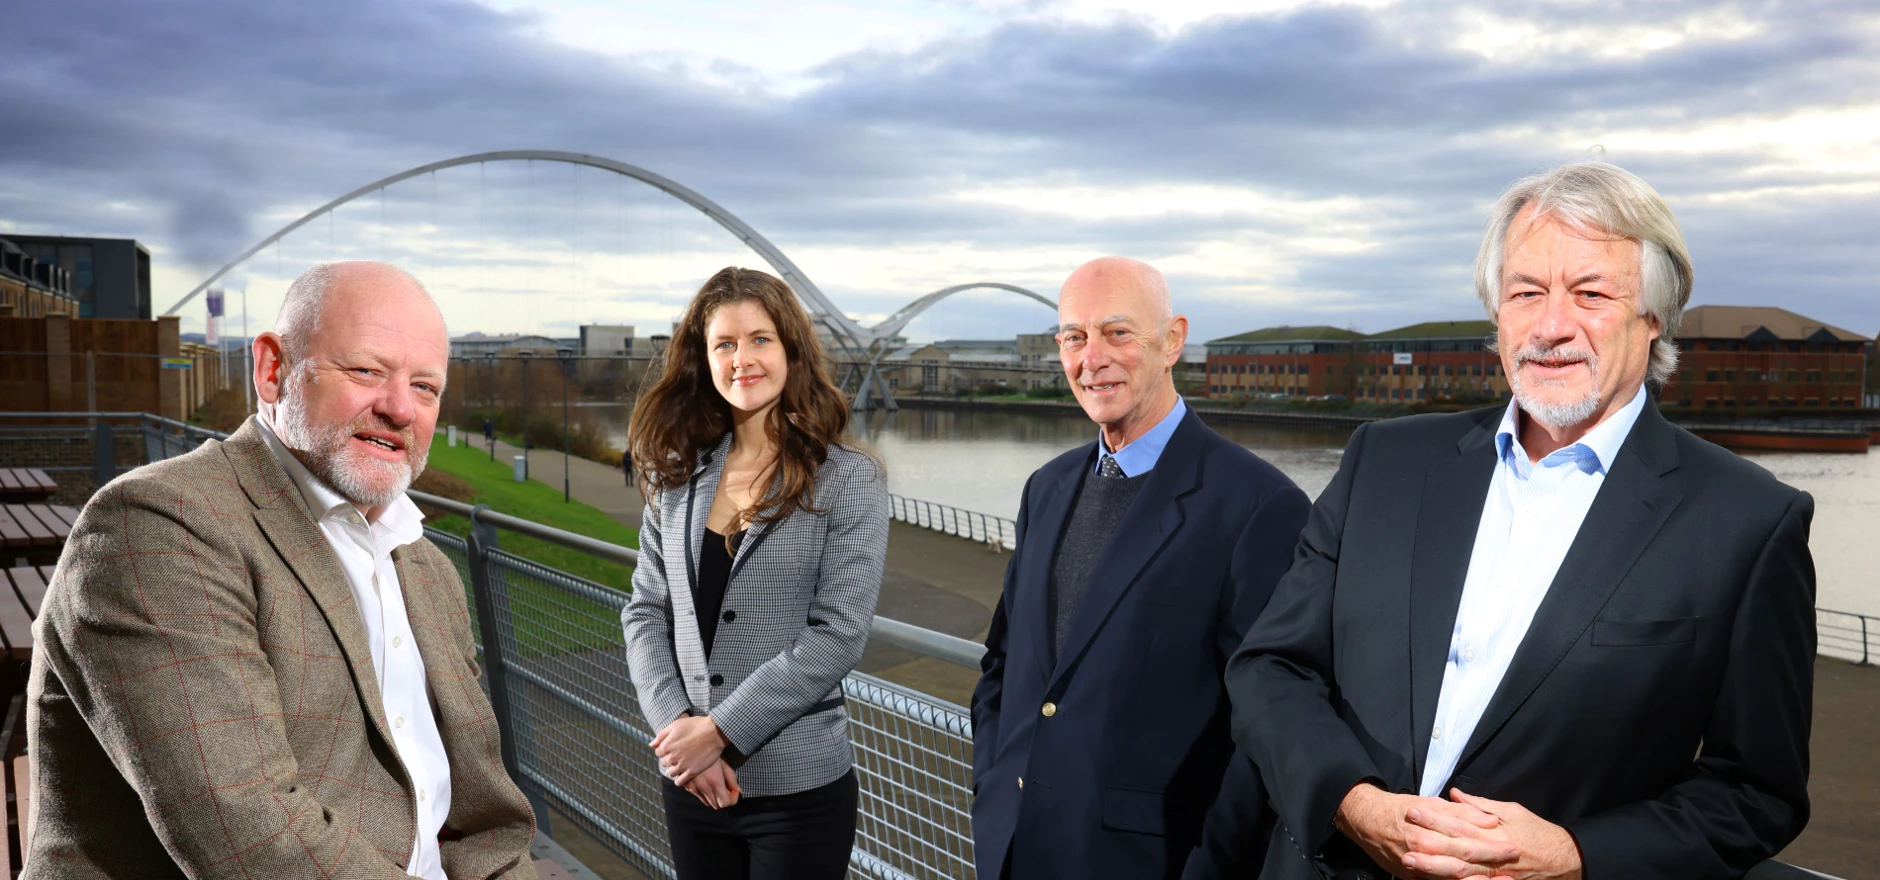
{"left": 972, "top": 258, "right": 1308, "bottom": 880}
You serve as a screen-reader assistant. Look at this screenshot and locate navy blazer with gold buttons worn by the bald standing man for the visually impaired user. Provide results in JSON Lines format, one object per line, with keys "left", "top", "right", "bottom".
{"left": 972, "top": 412, "right": 1308, "bottom": 880}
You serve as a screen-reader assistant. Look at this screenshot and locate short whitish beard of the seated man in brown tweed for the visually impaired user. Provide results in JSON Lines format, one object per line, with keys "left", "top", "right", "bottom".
{"left": 273, "top": 376, "right": 429, "bottom": 508}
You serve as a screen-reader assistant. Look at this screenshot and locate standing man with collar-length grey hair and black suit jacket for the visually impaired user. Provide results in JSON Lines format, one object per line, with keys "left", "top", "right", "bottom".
{"left": 1226, "top": 162, "right": 1814, "bottom": 880}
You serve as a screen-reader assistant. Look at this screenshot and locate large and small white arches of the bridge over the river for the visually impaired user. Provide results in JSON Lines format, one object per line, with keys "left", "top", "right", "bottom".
{"left": 164, "top": 150, "right": 1057, "bottom": 410}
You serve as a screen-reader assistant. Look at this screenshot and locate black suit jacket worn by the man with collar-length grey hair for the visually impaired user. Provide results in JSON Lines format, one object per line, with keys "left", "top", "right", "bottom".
{"left": 1228, "top": 404, "right": 1814, "bottom": 880}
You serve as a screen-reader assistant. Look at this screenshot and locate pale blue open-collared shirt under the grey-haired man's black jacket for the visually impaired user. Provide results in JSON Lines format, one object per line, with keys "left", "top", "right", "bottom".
{"left": 1419, "top": 387, "right": 1645, "bottom": 797}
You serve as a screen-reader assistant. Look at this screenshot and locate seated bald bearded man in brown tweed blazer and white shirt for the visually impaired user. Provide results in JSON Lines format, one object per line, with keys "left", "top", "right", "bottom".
{"left": 23, "top": 263, "right": 536, "bottom": 880}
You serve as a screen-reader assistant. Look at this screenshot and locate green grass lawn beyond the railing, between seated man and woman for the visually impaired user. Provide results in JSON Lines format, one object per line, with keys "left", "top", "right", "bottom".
{"left": 425, "top": 438, "right": 639, "bottom": 590}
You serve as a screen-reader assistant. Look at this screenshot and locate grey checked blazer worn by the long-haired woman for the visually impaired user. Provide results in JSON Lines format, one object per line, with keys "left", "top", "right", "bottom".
{"left": 620, "top": 434, "right": 887, "bottom": 797}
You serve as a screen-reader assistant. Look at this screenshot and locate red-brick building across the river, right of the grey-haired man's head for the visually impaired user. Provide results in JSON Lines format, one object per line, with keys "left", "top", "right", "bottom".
{"left": 1660, "top": 306, "right": 1872, "bottom": 414}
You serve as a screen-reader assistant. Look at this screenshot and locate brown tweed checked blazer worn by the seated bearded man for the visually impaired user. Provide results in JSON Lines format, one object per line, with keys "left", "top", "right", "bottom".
{"left": 23, "top": 419, "right": 536, "bottom": 880}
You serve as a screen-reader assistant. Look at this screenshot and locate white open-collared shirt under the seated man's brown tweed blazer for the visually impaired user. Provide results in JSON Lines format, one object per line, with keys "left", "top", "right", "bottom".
{"left": 256, "top": 417, "right": 451, "bottom": 880}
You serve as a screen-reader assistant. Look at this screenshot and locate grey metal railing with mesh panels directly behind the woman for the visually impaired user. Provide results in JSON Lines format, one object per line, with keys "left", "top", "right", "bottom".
{"left": 410, "top": 493, "right": 983, "bottom": 880}
